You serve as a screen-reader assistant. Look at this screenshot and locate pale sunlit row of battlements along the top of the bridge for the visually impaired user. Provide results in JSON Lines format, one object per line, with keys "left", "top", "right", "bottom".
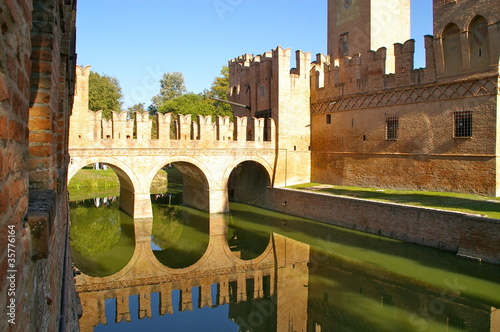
{"left": 70, "top": 110, "right": 276, "bottom": 148}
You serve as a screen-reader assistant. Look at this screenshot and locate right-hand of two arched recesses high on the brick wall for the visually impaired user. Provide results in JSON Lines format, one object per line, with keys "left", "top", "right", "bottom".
{"left": 469, "top": 16, "right": 490, "bottom": 70}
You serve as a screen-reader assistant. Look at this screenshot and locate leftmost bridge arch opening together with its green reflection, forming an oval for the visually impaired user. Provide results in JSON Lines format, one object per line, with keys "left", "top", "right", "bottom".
{"left": 68, "top": 163, "right": 135, "bottom": 277}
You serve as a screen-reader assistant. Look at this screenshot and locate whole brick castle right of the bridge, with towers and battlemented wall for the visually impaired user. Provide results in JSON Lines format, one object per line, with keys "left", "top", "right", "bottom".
{"left": 228, "top": 0, "right": 500, "bottom": 196}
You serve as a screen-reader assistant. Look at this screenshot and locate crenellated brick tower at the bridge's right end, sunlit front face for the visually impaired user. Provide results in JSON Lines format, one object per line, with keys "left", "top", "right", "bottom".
{"left": 229, "top": 47, "right": 311, "bottom": 187}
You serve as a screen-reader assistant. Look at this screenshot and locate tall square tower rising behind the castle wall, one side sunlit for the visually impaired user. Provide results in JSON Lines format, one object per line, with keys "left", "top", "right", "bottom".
{"left": 328, "top": 0, "right": 410, "bottom": 73}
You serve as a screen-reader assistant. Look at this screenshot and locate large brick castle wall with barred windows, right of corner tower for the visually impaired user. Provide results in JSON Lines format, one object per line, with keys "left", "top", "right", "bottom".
{"left": 311, "top": 0, "right": 500, "bottom": 196}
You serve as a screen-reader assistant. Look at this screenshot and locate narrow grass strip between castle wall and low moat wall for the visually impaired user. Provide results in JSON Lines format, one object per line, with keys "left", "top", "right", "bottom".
{"left": 289, "top": 183, "right": 500, "bottom": 219}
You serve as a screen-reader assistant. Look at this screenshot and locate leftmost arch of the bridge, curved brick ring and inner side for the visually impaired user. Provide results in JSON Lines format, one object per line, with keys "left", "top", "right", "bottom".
{"left": 68, "top": 156, "right": 145, "bottom": 218}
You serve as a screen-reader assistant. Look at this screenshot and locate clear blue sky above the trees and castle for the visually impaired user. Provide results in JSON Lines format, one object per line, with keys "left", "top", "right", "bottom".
{"left": 77, "top": 0, "right": 432, "bottom": 108}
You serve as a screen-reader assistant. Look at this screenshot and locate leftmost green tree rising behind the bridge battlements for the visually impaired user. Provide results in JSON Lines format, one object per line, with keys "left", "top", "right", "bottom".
{"left": 89, "top": 71, "right": 123, "bottom": 120}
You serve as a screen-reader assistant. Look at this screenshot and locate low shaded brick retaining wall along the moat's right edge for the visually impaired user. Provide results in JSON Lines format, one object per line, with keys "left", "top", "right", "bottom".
{"left": 251, "top": 188, "right": 500, "bottom": 265}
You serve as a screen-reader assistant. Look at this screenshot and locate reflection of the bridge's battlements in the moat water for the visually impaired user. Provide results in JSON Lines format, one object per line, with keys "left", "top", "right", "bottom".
{"left": 80, "top": 271, "right": 275, "bottom": 329}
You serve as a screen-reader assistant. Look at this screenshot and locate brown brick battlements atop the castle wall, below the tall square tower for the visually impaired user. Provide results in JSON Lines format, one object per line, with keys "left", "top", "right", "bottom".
{"left": 311, "top": 36, "right": 436, "bottom": 100}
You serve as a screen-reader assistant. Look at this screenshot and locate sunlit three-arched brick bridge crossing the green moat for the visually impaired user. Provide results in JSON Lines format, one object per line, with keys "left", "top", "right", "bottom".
{"left": 69, "top": 112, "right": 285, "bottom": 218}
